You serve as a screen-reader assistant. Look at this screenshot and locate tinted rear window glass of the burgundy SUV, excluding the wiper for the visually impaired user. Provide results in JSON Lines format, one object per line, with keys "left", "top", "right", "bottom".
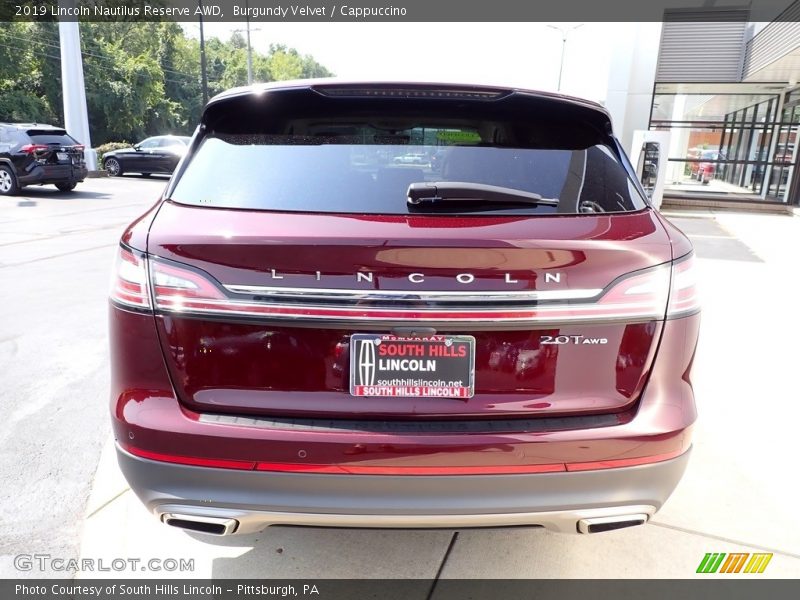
{"left": 171, "top": 107, "right": 645, "bottom": 215}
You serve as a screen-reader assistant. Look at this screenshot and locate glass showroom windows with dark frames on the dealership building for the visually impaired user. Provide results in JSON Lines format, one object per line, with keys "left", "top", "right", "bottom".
{"left": 650, "top": 83, "right": 800, "bottom": 202}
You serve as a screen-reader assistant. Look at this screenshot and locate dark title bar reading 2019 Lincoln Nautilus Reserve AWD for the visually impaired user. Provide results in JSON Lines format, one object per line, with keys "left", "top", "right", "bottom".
{"left": 0, "top": 0, "right": 800, "bottom": 22}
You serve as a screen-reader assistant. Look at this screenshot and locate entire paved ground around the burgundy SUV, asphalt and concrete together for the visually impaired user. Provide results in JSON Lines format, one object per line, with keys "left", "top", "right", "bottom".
{"left": 0, "top": 178, "right": 800, "bottom": 580}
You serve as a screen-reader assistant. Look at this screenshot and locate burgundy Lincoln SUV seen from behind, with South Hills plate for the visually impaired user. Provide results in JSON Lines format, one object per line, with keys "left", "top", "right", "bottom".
{"left": 110, "top": 80, "right": 699, "bottom": 534}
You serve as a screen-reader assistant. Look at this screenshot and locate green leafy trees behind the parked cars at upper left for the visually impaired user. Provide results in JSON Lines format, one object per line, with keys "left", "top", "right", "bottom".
{"left": 0, "top": 22, "right": 331, "bottom": 145}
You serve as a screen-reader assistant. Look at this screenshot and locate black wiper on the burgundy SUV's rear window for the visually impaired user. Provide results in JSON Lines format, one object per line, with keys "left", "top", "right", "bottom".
{"left": 408, "top": 181, "right": 558, "bottom": 206}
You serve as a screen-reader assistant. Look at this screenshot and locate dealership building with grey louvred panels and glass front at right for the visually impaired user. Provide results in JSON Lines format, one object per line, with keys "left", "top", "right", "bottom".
{"left": 605, "top": 0, "right": 800, "bottom": 208}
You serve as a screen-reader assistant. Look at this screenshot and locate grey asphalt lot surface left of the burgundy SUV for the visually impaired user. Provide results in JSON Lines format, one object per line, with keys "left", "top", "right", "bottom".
{"left": 0, "top": 178, "right": 166, "bottom": 577}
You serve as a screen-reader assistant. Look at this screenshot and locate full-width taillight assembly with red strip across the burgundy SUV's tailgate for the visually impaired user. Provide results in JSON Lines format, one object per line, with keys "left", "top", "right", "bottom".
{"left": 111, "top": 246, "right": 699, "bottom": 323}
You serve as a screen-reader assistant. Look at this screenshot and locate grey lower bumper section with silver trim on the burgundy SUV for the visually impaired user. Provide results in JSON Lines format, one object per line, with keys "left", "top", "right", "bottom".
{"left": 117, "top": 446, "right": 689, "bottom": 534}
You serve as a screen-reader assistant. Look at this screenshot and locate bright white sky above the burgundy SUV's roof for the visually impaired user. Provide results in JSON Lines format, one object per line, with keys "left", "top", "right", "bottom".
{"left": 185, "top": 22, "right": 620, "bottom": 101}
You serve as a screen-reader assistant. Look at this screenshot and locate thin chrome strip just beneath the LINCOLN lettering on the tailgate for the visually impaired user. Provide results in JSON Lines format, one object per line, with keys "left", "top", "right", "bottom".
{"left": 223, "top": 285, "right": 603, "bottom": 302}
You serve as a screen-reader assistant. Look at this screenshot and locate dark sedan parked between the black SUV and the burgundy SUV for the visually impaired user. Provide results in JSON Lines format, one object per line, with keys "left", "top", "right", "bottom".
{"left": 103, "top": 135, "right": 191, "bottom": 177}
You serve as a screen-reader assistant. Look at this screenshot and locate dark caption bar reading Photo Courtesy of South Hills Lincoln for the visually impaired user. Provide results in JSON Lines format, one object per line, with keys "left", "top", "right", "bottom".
{"left": 0, "top": 575, "right": 800, "bottom": 600}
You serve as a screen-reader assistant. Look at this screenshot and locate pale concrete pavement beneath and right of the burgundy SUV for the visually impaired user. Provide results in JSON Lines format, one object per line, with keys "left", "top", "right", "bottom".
{"left": 79, "top": 211, "right": 800, "bottom": 578}
